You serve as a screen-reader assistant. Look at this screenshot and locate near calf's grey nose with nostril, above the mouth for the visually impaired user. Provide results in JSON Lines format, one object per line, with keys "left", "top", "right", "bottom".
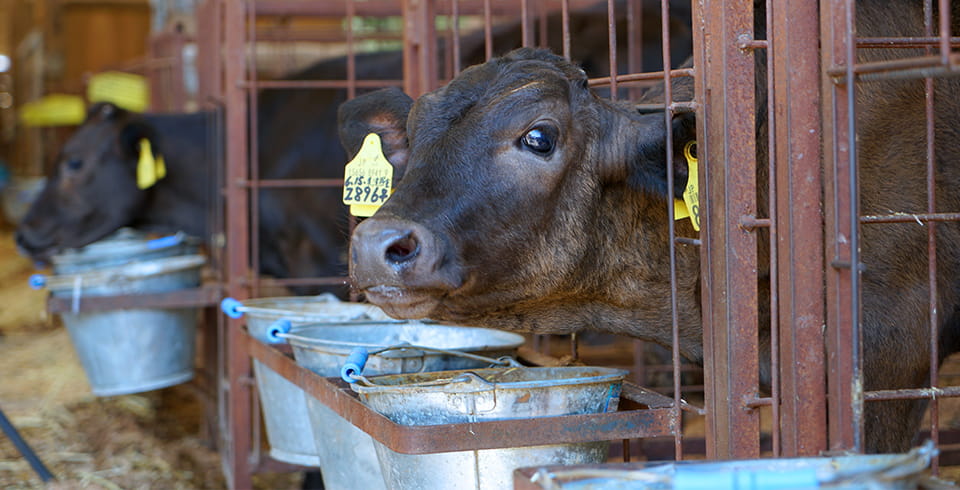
{"left": 350, "top": 218, "right": 460, "bottom": 289}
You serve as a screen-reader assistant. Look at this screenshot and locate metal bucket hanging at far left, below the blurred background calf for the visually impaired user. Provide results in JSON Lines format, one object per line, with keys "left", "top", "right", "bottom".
{"left": 42, "top": 251, "right": 206, "bottom": 396}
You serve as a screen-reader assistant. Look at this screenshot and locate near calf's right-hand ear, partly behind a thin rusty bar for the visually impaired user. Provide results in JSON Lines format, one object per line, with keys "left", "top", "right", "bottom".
{"left": 607, "top": 112, "right": 696, "bottom": 199}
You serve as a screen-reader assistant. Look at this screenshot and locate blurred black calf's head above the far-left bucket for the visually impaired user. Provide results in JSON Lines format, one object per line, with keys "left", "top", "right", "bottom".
{"left": 16, "top": 103, "right": 157, "bottom": 262}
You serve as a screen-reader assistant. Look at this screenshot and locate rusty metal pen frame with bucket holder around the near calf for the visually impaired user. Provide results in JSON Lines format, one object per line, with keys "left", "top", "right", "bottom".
{"left": 210, "top": 0, "right": 960, "bottom": 488}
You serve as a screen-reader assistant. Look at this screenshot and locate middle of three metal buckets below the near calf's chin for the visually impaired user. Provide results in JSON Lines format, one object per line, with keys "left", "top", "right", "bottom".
{"left": 284, "top": 322, "right": 524, "bottom": 489}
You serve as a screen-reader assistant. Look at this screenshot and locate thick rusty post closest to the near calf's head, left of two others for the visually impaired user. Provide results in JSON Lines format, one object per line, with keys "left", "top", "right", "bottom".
{"left": 694, "top": 0, "right": 760, "bottom": 459}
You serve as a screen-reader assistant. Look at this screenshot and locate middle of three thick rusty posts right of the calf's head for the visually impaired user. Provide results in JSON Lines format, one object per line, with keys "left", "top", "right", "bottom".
{"left": 767, "top": 0, "right": 827, "bottom": 457}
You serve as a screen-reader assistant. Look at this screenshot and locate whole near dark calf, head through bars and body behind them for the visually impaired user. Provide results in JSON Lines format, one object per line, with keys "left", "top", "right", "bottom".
{"left": 340, "top": 0, "right": 960, "bottom": 452}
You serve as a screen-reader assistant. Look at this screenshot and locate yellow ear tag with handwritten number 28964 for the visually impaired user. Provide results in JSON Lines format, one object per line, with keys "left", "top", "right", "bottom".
{"left": 343, "top": 133, "right": 393, "bottom": 217}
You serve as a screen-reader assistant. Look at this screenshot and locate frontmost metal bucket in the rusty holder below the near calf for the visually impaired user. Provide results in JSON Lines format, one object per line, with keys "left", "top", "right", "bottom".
{"left": 351, "top": 367, "right": 627, "bottom": 490}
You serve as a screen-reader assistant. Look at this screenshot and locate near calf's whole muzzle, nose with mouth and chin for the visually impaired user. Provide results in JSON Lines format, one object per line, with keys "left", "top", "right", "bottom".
{"left": 350, "top": 217, "right": 463, "bottom": 318}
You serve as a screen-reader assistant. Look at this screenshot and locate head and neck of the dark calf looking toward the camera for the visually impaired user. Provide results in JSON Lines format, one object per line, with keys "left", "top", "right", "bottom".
{"left": 340, "top": 49, "right": 699, "bottom": 340}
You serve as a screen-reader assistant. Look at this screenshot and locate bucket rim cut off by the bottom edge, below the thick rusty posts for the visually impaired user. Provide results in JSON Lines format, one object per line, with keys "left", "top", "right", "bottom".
{"left": 530, "top": 441, "right": 937, "bottom": 490}
